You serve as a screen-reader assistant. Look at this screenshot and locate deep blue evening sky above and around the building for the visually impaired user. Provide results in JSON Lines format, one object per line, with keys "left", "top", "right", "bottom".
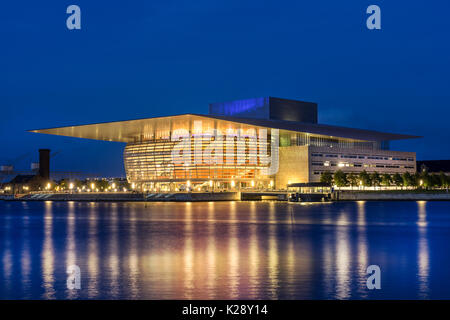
{"left": 0, "top": 0, "right": 450, "bottom": 176}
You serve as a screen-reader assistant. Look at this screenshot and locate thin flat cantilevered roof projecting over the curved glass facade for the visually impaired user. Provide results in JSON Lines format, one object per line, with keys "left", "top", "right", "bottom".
{"left": 28, "top": 114, "right": 420, "bottom": 142}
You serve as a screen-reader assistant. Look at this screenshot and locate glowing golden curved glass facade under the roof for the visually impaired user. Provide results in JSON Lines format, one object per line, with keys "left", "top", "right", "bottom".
{"left": 124, "top": 115, "right": 381, "bottom": 191}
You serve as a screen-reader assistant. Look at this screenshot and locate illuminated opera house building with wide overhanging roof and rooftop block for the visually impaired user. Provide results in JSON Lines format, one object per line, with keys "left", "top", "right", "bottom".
{"left": 31, "top": 97, "right": 417, "bottom": 192}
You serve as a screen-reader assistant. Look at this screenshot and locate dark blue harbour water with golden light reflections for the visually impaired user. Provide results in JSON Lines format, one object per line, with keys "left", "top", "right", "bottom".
{"left": 0, "top": 201, "right": 450, "bottom": 299}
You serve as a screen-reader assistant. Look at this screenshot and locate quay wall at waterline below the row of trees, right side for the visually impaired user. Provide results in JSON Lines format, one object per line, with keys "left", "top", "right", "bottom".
{"left": 333, "top": 191, "right": 450, "bottom": 201}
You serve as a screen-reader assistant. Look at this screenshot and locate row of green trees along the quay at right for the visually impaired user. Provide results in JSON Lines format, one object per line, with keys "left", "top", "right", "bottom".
{"left": 320, "top": 170, "right": 450, "bottom": 189}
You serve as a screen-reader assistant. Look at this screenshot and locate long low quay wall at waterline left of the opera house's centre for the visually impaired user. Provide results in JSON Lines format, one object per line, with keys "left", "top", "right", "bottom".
{"left": 0, "top": 192, "right": 240, "bottom": 201}
